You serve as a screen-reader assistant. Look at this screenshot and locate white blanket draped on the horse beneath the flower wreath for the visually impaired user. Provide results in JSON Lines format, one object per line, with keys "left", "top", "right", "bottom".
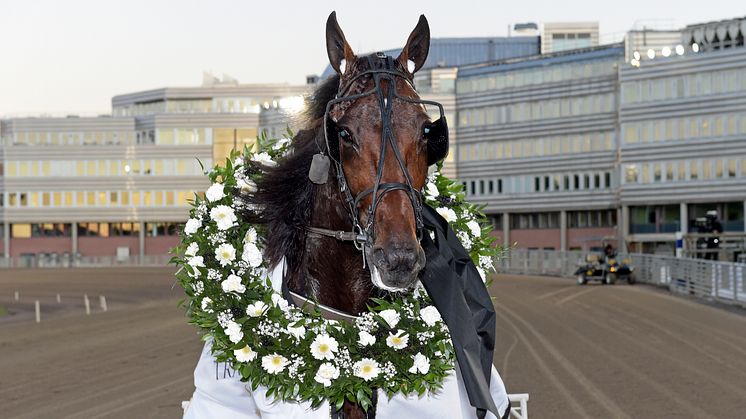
{"left": 184, "top": 263, "right": 510, "bottom": 419}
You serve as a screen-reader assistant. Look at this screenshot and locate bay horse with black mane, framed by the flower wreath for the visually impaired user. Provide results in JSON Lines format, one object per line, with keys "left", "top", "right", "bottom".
{"left": 244, "top": 12, "right": 448, "bottom": 419}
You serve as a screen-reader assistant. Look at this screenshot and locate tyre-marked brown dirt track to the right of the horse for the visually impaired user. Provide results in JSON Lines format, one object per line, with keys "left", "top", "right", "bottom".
{"left": 493, "top": 275, "right": 746, "bottom": 419}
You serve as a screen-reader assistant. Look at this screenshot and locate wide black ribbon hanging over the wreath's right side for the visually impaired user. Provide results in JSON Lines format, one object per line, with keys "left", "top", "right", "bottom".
{"left": 421, "top": 205, "right": 502, "bottom": 419}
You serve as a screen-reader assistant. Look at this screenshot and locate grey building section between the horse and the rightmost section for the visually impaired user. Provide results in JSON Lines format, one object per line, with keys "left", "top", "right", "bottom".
{"left": 456, "top": 45, "right": 624, "bottom": 249}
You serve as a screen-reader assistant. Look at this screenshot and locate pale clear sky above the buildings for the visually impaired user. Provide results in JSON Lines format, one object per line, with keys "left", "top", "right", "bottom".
{"left": 0, "top": 0, "right": 746, "bottom": 117}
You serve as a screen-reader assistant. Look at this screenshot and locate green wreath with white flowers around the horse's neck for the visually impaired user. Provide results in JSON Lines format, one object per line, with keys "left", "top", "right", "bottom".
{"left": 171, "top": 136, "right": 499, "bottom": 410}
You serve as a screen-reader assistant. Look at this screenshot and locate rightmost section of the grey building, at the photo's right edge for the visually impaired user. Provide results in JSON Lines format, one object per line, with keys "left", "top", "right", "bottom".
{"left": 619, "top": 33, "right": 746, "bottom": 253}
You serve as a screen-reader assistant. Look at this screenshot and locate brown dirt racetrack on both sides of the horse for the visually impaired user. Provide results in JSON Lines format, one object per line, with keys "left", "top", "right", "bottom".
{"left": 0, "top": 268, "right": 746, "bottom": 419}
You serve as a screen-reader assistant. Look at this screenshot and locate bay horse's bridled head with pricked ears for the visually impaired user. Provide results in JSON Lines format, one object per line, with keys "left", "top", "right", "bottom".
{"left": 325, "top": 13, "right": 447, "bottom": 291}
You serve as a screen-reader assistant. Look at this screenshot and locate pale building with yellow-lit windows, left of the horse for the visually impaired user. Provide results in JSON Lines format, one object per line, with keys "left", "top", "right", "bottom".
{"left": 0, "top": 77, "right": 307, "bottom": 265}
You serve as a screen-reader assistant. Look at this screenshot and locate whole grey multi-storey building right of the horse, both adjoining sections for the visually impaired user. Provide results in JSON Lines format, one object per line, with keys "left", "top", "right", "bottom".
{"left": 456, "top": 19, "right": 746, "bottom": 254}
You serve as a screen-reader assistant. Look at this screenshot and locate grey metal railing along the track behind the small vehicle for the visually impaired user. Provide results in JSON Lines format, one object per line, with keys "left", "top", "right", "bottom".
{"left": 496, "top": 249, "right": 746, "bottom": 307}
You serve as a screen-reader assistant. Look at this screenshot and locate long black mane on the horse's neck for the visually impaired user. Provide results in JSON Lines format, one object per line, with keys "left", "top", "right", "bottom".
{"left": 242, "top": 76, "right": 339, "bottom": 278}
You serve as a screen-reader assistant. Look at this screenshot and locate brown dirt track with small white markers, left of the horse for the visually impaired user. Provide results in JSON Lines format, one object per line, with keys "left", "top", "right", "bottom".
{"left": 0, "top": 268, "right": 202, "bottom": 419}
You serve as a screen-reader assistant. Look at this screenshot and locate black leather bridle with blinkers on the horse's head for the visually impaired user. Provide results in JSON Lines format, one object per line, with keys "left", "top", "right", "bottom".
{"left": 306, "top": 52, "right": 448, "bottom": 265}
